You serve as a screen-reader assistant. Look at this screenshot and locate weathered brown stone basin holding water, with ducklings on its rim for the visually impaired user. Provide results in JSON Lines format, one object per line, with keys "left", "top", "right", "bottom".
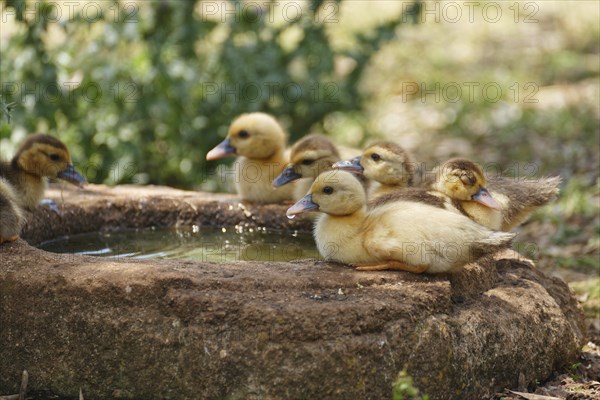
{"left": 0, "top": 185, "right": 585, "bottom": 400}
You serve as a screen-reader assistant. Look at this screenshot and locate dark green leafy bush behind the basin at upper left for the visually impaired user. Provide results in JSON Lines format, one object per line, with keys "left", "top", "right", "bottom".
{"left": 0, "top": 0, "right": 418, "bottom": 188}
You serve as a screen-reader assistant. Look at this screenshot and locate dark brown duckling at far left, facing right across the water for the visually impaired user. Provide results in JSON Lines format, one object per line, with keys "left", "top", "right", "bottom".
{"left": 0, "top": 133, "right": 86, "bottom": 210}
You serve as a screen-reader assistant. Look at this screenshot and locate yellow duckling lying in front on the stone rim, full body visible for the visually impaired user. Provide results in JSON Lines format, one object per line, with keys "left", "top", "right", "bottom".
{"left": 287, "top": 170, "right": 514, "bottom": 273}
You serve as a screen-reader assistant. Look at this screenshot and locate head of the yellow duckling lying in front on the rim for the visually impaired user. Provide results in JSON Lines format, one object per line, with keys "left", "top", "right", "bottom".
{"left": 287, "top": 170, "right": 367, "bottom": 217}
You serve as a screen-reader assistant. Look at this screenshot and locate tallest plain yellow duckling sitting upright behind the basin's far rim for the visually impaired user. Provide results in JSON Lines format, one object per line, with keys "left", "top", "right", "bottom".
{"left": 206, "top": 113, "right": 294, "bottom": 203}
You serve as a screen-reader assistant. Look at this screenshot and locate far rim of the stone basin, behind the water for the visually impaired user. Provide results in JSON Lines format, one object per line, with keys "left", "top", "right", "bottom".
{"left": 22, "top": 185, "right": 312, "bottom": 244}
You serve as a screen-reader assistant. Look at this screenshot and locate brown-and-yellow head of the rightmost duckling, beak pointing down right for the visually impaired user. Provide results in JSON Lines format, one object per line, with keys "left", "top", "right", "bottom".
{"left": 433, "top": 158, "right": 501, "bottom": 209}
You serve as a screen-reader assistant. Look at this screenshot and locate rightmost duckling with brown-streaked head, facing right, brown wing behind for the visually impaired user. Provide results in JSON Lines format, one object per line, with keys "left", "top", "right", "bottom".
{"left": 425, "top": 158, "right": 560, "bottom": 231}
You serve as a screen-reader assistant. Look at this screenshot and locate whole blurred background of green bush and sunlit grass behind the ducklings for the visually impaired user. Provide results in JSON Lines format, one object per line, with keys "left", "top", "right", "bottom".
{"left": 0, "top": 0, "right": 600, "bottom": 329}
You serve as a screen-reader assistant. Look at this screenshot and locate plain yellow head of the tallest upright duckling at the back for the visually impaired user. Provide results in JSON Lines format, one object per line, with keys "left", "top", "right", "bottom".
{"left": 206, "top": 113, "right": 286, "bottom": 160}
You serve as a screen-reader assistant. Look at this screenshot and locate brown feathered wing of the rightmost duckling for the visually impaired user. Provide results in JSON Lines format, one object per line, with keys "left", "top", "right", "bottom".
{"left": 487, "top": 176, "right": 561, "bottom": 230}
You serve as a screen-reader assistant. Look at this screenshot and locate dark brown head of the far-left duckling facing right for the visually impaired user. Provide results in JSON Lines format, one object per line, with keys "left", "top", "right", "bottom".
{"left": 12, "top": 133, "right": 86, "bottom": 186}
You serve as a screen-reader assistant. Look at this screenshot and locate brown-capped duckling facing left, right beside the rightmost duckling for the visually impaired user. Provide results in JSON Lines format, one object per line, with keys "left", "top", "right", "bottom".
{"left": 333, "top": 142, "right": 416, "bottom": 198}
